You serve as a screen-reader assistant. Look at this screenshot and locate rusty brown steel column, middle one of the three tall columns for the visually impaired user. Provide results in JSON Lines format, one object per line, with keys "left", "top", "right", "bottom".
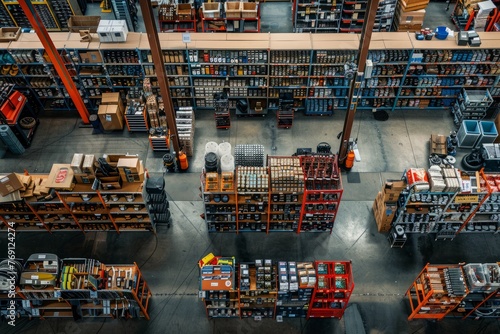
{"left": 139, "top": 0, "right": 181, "bottom": 160}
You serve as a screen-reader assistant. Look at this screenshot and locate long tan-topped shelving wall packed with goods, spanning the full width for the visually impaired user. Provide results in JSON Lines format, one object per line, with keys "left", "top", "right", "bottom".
{"left": 0, "top": 32, "right": 500, "bottom": 116}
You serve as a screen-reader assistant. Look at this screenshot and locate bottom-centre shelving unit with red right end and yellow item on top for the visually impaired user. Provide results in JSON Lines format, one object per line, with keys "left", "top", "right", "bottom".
{"left": 198, "top": 254, "right": 354, "bottom": 321}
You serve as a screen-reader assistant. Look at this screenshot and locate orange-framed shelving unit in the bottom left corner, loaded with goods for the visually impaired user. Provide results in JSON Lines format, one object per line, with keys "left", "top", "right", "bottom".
{"left": 8, "top": 253, "right": 152, "bottom": 320}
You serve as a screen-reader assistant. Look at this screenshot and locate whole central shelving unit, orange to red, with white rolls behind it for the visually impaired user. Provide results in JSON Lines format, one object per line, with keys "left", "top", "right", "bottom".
{"left": 201, "top": 155, "right": 343, "bottom": 233}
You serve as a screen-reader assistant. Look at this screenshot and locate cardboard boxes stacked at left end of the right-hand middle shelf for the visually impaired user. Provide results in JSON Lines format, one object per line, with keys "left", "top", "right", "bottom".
{"left": 373, "top": 180, "right": 406, "bottom": 232}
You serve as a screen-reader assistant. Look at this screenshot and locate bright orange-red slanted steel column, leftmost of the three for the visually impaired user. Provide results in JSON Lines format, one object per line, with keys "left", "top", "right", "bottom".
{"left": 18, "top": 0, "right": 90, "bottom": 124}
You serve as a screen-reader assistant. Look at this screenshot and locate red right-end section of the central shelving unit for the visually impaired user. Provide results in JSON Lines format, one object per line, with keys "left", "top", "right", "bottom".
{"left": 299, "top": 155, "right": 343, "bottom": 233}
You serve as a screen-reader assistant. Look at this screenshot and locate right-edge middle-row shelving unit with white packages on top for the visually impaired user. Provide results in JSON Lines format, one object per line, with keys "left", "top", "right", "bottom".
{"left": 391, "top": 169, "right": 500, "bottom": 243}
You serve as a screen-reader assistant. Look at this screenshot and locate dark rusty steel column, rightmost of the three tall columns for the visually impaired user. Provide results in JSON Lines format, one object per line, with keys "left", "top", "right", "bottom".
{"left": 339, "top": 0, "right": 379, "bottom": 165}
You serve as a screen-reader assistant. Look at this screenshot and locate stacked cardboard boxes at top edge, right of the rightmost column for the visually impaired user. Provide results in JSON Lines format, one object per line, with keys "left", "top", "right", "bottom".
{"left": 393, "top": 0, "right": 429, "bottom": 31}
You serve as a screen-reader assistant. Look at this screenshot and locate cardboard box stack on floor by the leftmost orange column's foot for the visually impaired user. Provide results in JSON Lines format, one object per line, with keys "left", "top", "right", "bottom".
{"left": 97, "top": 93, "right": 125, "bottom": 131}
